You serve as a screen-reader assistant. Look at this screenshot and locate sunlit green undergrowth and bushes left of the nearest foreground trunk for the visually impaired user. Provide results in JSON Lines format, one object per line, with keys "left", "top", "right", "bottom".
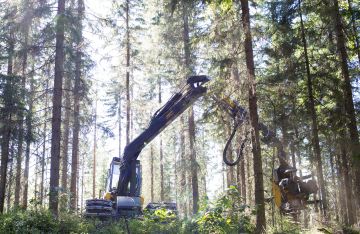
{"left": 0, "top": 187, "right": 254, "bottom": 234}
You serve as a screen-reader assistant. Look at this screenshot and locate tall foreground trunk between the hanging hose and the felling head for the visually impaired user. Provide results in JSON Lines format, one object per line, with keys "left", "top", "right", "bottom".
{"left": 240, "top": 0, "right": 266, "bottom": 230}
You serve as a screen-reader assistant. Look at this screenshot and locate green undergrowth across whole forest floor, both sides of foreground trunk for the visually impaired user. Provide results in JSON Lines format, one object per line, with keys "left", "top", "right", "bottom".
{"left": 0, "top": 187, "right": 360, "bottom": 234}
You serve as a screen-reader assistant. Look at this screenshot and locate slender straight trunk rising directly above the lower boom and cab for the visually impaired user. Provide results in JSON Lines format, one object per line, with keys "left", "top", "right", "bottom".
{"left": 125, "top": 0, "right": 131, "bottom": 145}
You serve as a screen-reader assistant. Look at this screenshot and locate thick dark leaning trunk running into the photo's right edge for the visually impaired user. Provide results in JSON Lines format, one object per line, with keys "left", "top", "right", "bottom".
{"left": 333, "top": 0, "right": 360, "bottom": 208}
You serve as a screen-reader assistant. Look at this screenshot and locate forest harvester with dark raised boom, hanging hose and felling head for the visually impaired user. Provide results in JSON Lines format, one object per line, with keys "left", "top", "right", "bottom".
{"left": 85, "top": 75, "right": 317, "bottom": 219}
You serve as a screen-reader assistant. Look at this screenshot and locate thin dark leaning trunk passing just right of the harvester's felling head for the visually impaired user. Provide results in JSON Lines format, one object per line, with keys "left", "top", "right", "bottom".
{"left": 299, "top": 0, "right": 327, "bottom": 218}
